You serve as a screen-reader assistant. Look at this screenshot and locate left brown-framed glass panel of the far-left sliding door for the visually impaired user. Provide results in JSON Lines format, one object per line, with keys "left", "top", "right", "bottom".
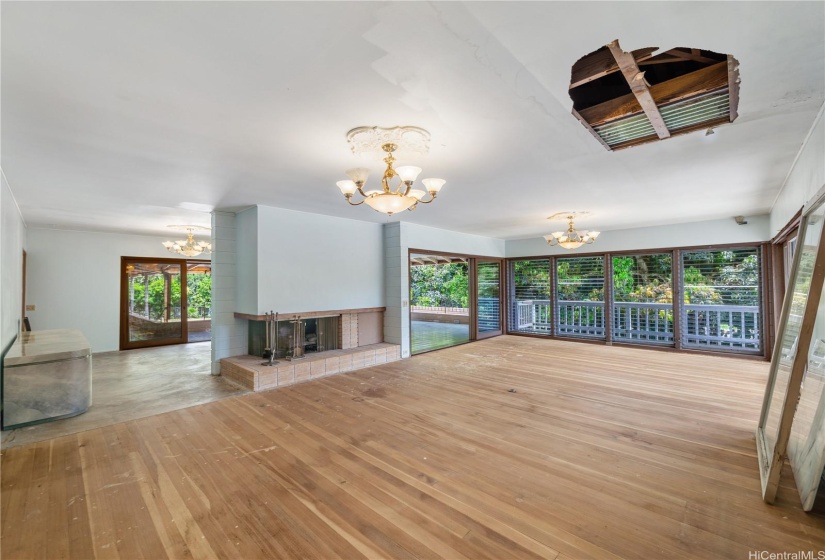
{"left": 120, "top": 257, "right": 187, "bottom": 350}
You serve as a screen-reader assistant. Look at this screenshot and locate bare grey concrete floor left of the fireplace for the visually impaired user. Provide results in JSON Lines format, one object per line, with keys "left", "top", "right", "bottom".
{"left": 0, "top": 342, "right": 247, "bottom": 448}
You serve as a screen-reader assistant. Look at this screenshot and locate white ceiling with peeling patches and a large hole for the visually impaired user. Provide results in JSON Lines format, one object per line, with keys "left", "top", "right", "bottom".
{"left": 0, "top": 1, "right": 825, "bottom": 238}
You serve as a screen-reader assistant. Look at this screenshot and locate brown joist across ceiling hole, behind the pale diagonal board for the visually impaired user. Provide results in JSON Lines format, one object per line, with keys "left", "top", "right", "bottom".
{"left": 579, "top": 61, "right": 733, "bottom": 126}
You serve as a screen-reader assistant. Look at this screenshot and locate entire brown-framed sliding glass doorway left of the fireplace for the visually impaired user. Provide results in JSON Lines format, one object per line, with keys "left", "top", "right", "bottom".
{"left": 120, "top": 257, "right": 212, "bottom": 350}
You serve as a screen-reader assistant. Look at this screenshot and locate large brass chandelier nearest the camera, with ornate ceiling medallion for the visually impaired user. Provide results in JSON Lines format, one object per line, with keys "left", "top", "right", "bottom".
{"left": 337, "top": 126, "right": 447, "bottom": 216}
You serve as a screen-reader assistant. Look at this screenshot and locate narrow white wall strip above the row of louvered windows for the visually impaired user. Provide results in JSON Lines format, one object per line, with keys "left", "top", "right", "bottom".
{"left": 507, "top": 216, "right": 771, "bottom": 257}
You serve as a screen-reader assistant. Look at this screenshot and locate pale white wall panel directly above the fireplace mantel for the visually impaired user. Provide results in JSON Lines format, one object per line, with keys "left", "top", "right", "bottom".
{"left": 257, "top": 206, "right": 384, "bottom": 314}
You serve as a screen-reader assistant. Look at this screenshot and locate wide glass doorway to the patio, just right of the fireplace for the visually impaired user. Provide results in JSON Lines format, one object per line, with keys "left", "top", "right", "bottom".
{"left": 409, "top": 251, "right": 503, "bottom": 354}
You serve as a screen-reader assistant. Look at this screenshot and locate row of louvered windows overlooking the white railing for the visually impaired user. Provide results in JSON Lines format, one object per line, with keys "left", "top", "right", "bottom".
{"left": 507, "top": 246, "right": 764, "bottom": 354}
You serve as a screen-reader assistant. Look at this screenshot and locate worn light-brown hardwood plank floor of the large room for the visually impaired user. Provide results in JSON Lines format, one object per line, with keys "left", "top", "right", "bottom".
{"left": 0, "top": 336, "right": 825, "bottom": 560}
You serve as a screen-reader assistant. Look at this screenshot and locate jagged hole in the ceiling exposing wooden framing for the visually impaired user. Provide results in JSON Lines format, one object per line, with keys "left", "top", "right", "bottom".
{"left": 570, "top": 40, "right": 739, "bottom": 151}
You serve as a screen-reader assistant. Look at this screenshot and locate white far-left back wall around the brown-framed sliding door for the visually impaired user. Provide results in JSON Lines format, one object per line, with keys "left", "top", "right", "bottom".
{"left": 26, "top": 228, "right": 208, "bottom": 352}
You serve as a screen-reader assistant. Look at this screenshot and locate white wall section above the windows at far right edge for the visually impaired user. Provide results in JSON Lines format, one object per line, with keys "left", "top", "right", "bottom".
{"left": 770, "top": 105, "right": 825, "bottom": 237}
